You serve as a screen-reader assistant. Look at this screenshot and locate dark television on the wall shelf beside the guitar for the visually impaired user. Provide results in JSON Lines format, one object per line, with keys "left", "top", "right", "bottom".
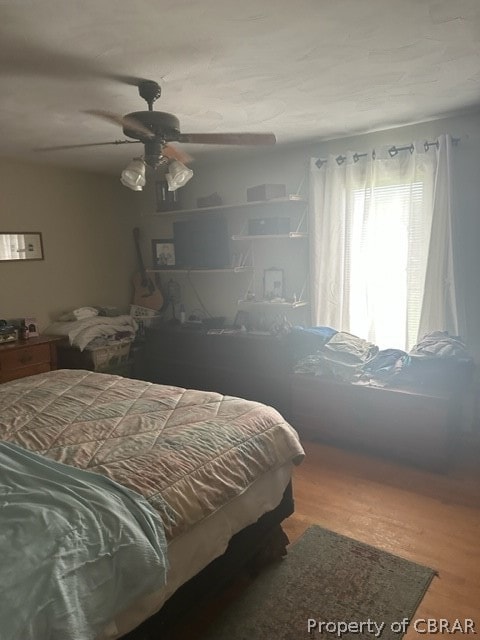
{"left": 173, "top": 216, "right": 230, "bottom": 269}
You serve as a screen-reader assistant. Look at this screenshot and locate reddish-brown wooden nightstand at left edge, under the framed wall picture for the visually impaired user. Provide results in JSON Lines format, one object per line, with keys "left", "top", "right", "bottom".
{"left": 0, "top": 336, "right": 58, "bottom": 383}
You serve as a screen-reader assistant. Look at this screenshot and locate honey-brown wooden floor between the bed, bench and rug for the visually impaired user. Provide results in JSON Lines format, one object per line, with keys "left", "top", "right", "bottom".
{"left": 284, "top": 441, "right": 480, "bottom": 640}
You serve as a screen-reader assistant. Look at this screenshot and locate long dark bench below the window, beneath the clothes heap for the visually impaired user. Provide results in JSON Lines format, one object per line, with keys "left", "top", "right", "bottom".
{"left": 290, "top": 374, "right": 462, "bottom": 471}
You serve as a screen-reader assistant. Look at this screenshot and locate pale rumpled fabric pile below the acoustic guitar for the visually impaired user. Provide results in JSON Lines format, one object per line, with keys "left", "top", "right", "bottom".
{"left": 45, "top": 307, "right": 138, "bottom": 351}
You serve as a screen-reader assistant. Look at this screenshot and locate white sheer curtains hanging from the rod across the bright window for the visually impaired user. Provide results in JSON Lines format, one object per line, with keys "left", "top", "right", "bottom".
{"left": 310, "top": 136, "right": 458, "bottom": 350}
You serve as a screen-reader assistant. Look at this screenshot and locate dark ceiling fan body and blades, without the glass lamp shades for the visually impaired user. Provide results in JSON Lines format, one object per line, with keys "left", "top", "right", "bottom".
{"left": 35, "top": 79, "right": 276, "bottom": 169}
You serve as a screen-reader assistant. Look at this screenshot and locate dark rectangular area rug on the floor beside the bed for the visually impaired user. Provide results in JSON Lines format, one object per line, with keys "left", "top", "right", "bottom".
{"left": 202, "top": 526, "right": 435, "bottom": 640}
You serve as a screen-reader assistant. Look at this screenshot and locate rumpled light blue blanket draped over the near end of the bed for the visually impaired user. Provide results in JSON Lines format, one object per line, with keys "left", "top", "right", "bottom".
{"left": 0, "top": 442, "right": 167, "bottom": 640}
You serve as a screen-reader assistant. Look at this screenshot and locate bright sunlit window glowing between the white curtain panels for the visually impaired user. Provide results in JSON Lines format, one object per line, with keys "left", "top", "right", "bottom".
{"left": 346, "top": 181, "right": 428, "bottom": 349}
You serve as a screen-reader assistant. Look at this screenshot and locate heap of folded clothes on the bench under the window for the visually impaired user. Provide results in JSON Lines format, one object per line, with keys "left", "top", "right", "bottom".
{"left": 293, "top": 327, "right": 474, "bottom": 392}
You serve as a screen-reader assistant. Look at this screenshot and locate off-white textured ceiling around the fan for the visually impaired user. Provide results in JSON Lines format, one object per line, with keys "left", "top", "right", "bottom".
{"left": 0, "top": 0, "right": 480, "bottom": 172}
